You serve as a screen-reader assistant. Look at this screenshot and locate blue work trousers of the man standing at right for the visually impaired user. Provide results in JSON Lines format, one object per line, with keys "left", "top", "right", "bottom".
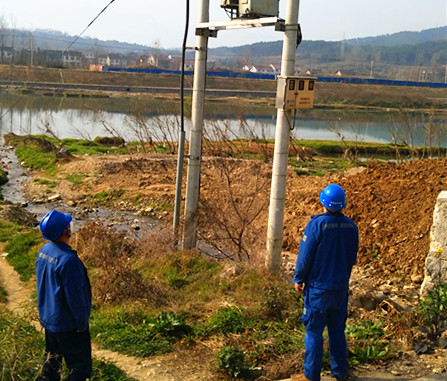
{"left": 301, "top": 285, "right": 349, "bottom": 381}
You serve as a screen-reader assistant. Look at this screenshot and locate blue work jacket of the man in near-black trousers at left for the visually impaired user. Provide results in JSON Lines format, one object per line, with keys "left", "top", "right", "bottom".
{"left": 36, "top": 241, "right": 92, "bottom": 332}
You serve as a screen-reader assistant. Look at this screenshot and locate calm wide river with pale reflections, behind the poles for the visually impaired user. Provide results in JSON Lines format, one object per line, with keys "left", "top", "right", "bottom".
{"left": 0, "top": 96, "right": 447, "bottom": 147}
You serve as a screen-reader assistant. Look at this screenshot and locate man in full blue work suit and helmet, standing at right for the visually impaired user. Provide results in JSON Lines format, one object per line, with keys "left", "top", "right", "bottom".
{"left": 292, "top": 184, "right": 359, "bottom": 381}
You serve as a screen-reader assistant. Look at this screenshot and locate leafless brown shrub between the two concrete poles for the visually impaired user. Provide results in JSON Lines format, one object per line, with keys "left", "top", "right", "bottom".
{"left": 198, "top": 158, "right": 270, "bottom": 261}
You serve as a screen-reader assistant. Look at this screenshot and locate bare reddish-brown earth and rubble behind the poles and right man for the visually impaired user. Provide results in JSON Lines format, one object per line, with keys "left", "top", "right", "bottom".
{"left": 3, "top": 154, "right": 447, "bottom": 379}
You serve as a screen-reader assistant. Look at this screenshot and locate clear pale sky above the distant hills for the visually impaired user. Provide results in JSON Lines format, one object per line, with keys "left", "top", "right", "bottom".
{"left": 0, "top": 0, "right": 447, "bottom": 48}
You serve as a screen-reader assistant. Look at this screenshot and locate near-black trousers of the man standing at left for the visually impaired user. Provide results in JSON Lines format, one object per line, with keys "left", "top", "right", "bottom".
{"left": 37, "top": 330, "right": 92, "bottom": 381}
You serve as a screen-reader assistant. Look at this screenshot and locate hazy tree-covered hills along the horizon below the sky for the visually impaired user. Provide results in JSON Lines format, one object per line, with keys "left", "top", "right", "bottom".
{"left": 0, "top": 26, "right": 447, "bottom": 70}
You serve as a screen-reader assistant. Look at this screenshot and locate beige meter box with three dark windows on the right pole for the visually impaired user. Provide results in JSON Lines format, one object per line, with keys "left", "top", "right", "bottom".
{"left": 276, "top": 76, "right": 317, "bottom": 110}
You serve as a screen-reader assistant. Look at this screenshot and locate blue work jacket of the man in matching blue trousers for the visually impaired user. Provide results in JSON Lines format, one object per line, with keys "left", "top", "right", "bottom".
{"left": 293, "top": 212, "right": 359, "bottom": 290}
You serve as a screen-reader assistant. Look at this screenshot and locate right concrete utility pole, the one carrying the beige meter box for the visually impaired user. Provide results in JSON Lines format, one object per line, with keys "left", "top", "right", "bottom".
{"left": 265, "top": 0, "right": 300, "bottom": 273}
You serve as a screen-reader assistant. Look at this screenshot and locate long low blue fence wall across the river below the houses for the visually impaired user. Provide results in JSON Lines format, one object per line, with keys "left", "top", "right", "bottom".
{"left": 102, "top": 68, "right": 447, "bottom": 89}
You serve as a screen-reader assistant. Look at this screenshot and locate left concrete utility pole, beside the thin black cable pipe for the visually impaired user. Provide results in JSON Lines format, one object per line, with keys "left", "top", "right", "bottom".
{"left": 183, "top": 0, "right": 209, "bottom": 250}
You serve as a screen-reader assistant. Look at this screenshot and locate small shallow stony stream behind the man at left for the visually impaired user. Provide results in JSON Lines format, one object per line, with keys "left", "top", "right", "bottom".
{"left": 0, "top": 142, "right": 158, "bottom": 237}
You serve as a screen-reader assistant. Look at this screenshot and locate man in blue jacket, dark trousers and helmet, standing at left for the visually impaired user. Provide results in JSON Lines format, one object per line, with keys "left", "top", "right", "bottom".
{"left": 36, "top": 210, "right": 92, "bottom": 381}
